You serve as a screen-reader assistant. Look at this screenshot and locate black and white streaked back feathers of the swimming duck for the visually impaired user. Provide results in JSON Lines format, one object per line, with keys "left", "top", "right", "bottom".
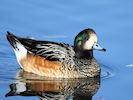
{"left": 18, "top": 38, "right": 75, "bottom": 67}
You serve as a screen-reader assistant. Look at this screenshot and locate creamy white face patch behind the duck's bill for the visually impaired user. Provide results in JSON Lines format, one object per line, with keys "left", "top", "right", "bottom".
{"left": 84, "top": 34, "right": 98, "bottom": 50}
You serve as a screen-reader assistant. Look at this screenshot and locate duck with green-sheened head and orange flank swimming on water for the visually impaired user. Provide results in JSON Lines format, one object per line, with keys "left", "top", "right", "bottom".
{"left": 7, "top": 28, "right": 106, "bottom": 78}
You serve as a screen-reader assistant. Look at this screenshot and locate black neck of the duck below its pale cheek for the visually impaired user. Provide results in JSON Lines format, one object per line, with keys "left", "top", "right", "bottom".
{"left": 75, "top": 50, "right": 93, "bottom": 59}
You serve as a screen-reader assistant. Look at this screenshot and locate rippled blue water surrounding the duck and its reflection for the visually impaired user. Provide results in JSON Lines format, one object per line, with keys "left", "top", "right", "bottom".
{"left": 0, "top": 0, "right": 133, "bottom": 100}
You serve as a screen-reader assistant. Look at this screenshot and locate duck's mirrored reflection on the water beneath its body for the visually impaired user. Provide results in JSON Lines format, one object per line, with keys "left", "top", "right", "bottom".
{"left": 6, "top": 70, "right": 100, "bottom": 100}
